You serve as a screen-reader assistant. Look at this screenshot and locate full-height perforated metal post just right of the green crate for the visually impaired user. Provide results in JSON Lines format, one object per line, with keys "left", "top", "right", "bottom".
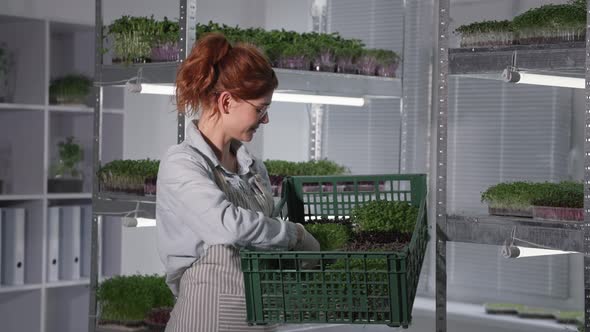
{"left": 434, "top": 0, "right": 450, "bottom": 332}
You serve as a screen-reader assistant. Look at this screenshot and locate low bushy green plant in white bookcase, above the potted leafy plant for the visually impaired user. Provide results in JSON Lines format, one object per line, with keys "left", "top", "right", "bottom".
{"left": 49, "top": 74, "right": 92, "bottom": 104}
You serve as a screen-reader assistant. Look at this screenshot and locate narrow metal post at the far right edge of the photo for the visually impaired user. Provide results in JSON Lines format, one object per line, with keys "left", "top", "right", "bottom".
{"left": 582, "top": 0, "right": 590, "bottom": 332}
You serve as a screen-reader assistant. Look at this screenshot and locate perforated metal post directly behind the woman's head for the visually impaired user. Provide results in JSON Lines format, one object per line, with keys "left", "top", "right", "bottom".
{"left": 176, "top": 0, "right": 197, "bottom": 143}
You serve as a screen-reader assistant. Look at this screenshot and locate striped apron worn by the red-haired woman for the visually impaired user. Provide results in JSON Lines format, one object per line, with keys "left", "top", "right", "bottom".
{"left": 166, "top": 151, "right": 277, "bottom": 332}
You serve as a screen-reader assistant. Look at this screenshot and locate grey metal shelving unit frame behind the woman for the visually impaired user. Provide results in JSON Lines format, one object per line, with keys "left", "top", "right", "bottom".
{"left": 89, "top": 0, "right": 402, "bottom": 332}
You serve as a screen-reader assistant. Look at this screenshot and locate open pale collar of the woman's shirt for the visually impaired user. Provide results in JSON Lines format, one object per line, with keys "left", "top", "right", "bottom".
{"left": 185, "top": 121, "right": 254, "bottom": 175}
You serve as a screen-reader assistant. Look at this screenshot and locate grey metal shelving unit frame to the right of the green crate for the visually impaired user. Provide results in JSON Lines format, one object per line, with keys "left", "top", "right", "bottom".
{"left": 433, "top": 0, "right": 590, "bottom": 332}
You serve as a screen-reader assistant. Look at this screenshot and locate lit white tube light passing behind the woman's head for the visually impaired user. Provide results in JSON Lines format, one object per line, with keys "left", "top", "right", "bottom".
{"left": 126, "top": 82, "right": 365, "bottom": 107}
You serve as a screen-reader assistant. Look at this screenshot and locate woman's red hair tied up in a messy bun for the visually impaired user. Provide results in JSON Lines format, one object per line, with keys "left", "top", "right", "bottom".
{"left": 176, "top": 33, "right": 279, "bottom": 114}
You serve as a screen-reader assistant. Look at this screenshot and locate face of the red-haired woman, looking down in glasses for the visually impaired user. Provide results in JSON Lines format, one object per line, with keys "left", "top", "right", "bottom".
{"left": 224, "top": 91, "right": 272, "bottom": 142}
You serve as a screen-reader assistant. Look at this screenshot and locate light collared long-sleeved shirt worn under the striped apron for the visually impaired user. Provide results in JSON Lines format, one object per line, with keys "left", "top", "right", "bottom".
{"left": 156, "top": 123, "right": 297, "bottom": 295}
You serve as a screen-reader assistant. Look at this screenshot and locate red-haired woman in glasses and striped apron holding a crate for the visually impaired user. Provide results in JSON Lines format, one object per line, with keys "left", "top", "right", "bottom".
{"left": 156, "top": 34, "right": 319, "bottom": 332}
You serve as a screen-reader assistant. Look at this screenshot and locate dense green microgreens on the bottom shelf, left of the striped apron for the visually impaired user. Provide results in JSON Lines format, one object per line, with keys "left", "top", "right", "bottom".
{"left": 96, "top": 275, "right": 174, "bottom": 322}
